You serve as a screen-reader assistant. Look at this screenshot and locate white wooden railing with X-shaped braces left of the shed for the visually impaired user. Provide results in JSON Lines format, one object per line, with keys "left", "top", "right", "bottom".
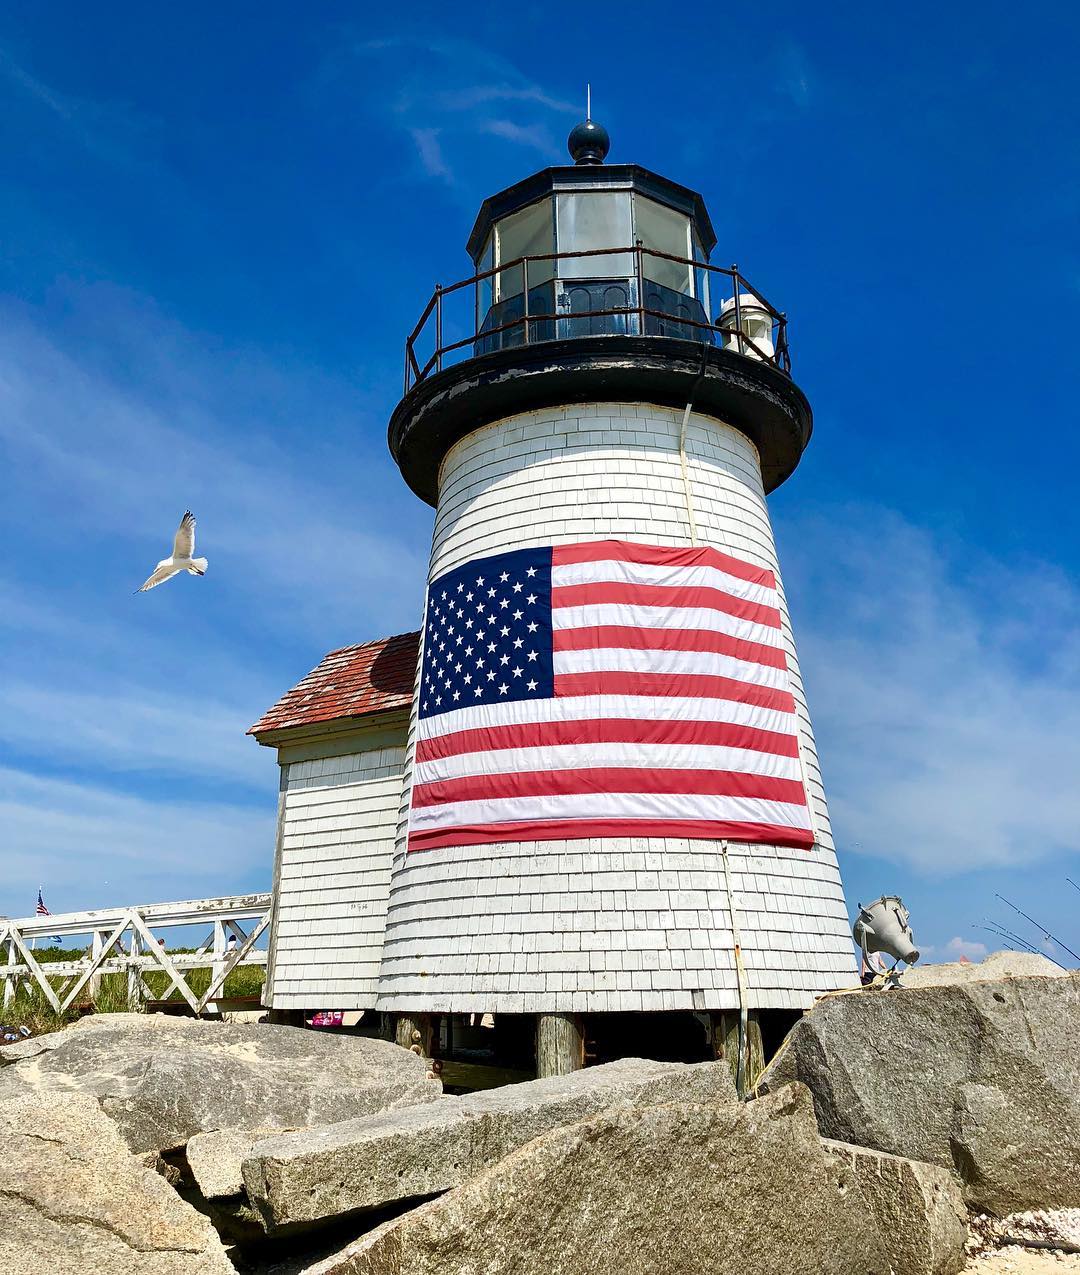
{"left": 0, "top": 894, "right": 272, "bottom": 1014}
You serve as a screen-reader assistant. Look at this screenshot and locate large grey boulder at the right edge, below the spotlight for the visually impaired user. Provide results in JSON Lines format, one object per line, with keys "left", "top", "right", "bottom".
{"left": 760, "top": 974, "right": 1080, "bottom": 1214}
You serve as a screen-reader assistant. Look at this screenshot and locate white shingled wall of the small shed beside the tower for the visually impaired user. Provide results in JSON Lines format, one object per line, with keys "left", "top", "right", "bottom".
{"left": 272, "top": 739, "right": 405, "bottom": 1010}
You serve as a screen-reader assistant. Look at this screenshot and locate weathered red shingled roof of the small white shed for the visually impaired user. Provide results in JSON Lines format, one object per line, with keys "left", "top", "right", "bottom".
{"left": 247, "top": 634, "right": 420, "bottom": 734}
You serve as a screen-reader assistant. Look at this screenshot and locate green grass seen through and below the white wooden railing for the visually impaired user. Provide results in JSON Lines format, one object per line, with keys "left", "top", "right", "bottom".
{"left": 0, "top": 947, "right": 264, "bottom": 1035}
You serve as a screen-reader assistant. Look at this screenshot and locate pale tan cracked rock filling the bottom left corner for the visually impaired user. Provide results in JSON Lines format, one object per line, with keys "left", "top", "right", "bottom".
{"left": 0, "top": 1093, "right": 235, "bottom": 1275}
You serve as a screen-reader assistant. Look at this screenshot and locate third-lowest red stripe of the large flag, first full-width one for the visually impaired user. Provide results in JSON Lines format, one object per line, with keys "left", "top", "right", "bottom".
{"left": 416, "top": 718, "right": 798, "bottom": 762}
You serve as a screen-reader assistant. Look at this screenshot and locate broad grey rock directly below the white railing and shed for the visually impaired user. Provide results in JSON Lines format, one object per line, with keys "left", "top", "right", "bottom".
{"left": 0, "top": 1014, "right": 442, "bottom": 1151}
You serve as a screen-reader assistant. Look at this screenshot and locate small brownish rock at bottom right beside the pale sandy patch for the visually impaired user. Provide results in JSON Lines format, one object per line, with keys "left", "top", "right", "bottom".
{"left": 822, "top": 1139, "right": 968, "bottom": 1275}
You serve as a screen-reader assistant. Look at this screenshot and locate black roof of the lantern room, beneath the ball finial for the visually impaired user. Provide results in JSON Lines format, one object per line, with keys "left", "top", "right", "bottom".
{"left": 465, "top": 163, "right": 717, "bottom": 261}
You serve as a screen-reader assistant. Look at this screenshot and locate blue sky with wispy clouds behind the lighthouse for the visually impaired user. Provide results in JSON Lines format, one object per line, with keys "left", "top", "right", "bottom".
{"left": 0, "top": 3, "right": 1080, "bottom": 956}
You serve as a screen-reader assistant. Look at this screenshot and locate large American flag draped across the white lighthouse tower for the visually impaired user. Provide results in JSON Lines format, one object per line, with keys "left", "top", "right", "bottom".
{"left": 409, "top": 541, "right": 814, "bottom": 850}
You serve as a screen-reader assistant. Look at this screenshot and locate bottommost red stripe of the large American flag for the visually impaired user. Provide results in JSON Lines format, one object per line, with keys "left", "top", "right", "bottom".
{"left": 409, "top": 819, "right": 814, "bottom": 850}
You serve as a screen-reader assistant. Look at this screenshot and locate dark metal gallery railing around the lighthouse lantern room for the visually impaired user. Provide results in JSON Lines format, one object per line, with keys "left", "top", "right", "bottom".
{"left": 404, "top": 242, "right": 791, "bottom": 393}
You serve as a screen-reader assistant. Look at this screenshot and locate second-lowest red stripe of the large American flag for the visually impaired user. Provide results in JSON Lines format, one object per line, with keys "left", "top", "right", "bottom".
{"left": 413, "top": 766, "right": 806, "bottom": 810}
